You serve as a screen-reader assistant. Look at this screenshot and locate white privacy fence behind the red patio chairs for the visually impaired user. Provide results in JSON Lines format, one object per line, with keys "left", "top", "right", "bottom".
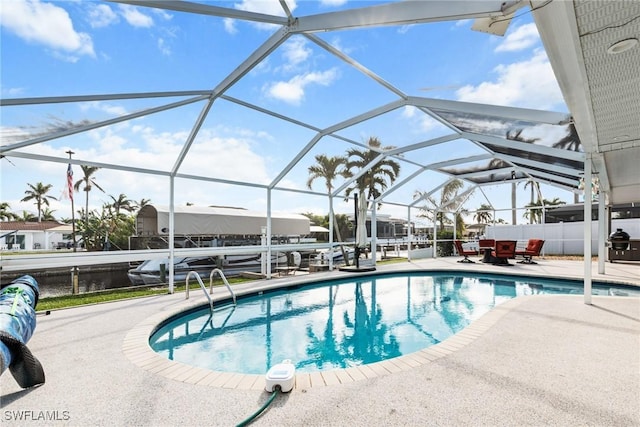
{"left": 485, "top": 218, "right": 640, "bottom": 255}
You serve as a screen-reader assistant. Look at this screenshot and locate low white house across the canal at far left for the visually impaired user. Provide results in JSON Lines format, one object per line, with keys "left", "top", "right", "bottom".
{"left": 0, "top": 221, "right": 73, "bottom": 251}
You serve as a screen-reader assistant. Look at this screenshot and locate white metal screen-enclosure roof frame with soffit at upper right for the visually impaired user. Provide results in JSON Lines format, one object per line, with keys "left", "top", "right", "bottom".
{"left": 0, "top": 0, "right": 640, "bottom": 213}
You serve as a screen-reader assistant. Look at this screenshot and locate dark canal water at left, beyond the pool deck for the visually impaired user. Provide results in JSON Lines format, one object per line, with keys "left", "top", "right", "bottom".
{"left": 2, "top": 264, "right": 132, "bottom": 298}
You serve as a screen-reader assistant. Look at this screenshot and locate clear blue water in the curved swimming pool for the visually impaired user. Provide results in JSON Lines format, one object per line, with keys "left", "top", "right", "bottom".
{"left": 150, "top": 273, "right": 640, "bottom": 374}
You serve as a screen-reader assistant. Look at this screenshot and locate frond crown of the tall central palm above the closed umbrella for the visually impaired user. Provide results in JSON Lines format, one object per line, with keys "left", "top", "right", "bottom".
{"left": 345, "top": 136, "right": 400, "bottom": 206}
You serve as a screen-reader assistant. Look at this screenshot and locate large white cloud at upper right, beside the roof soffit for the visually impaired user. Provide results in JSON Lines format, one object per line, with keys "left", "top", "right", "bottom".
{"left": 456, "top": 49, "right": 563, "bottom": 109}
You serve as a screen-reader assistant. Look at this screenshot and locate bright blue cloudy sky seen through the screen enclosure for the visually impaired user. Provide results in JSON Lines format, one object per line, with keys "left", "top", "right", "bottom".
{"left": 0, "top": 0, "right": 573, "bottom": 227}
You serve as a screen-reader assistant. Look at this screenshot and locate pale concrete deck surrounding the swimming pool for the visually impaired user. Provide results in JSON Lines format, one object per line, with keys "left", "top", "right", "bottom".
{"left": 0, "top": 257, "right": 640, "bottom": 426}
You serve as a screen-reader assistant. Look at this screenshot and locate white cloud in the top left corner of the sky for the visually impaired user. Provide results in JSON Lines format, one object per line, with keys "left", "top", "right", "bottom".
{"left": 0, "top": 0, "right": 95, "bottom": 57}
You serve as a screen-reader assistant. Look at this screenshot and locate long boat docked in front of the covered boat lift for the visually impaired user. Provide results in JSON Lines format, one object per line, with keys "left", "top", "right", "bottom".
{"left": 127, "top": 252, "right": 287, "bottom": 286}
